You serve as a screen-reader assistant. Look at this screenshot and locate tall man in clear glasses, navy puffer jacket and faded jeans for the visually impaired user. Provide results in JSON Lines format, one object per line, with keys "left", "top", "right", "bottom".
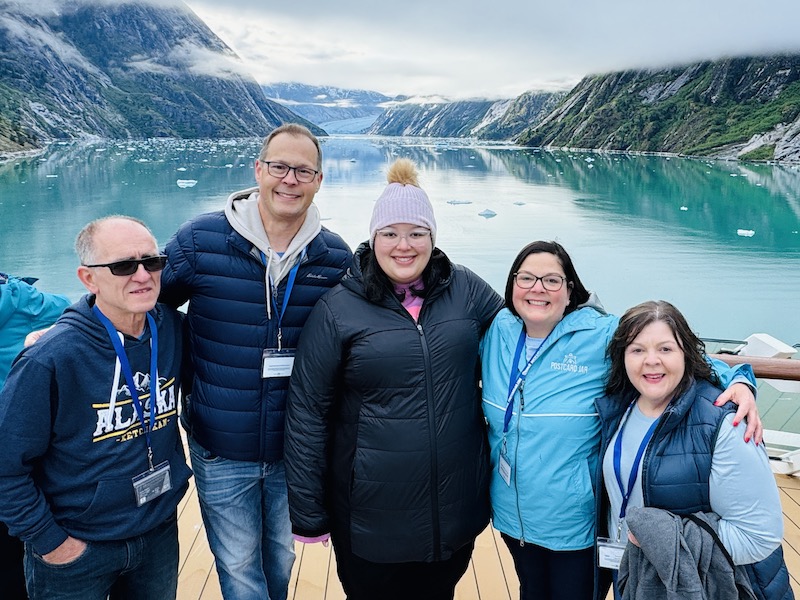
{"left": 161, "top": 124, "right": 352, "bottom": 600}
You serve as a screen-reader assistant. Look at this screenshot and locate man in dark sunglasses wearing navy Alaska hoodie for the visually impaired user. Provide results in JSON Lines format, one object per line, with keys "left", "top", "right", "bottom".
{"left": 0, "top": 216, "right": 191, "bottom": 600}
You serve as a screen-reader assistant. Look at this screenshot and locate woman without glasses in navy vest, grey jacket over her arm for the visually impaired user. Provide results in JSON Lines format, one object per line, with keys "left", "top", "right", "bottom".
{"left": 597, "top": 301, "right": 793, "bottom": 600}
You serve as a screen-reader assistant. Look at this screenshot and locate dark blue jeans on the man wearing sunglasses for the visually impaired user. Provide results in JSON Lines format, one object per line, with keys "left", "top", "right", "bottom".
{"left": 25, "top": 517, "right": 178, "bottom": 600}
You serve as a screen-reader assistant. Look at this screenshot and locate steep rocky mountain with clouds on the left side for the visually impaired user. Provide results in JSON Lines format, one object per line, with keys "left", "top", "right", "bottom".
{"left": 0, "top": 0, "right": 324, "bottom": 151}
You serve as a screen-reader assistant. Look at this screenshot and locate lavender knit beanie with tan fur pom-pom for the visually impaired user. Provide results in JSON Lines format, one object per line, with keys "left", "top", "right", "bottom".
{"left": 369, "top": 158, "right": 436, "bottom": 247}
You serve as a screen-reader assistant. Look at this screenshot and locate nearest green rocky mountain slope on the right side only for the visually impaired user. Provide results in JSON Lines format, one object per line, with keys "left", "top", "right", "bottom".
{"left": 519, "top": 56, "right": 800, "bottom": 161}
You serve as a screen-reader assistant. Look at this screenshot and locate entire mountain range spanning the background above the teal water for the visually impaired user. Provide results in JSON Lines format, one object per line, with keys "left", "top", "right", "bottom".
{"left": 0, "top": 0, "right": 800, "bottom": 162}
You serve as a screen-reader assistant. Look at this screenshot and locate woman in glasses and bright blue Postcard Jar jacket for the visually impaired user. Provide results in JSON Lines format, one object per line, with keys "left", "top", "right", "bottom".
{"left": 481, "top": 241, "right": 761, "bottom": 600}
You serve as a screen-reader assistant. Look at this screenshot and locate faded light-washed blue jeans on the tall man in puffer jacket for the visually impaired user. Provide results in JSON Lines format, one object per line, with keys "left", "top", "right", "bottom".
{"left": 189, "top": 438, "right": 294, "bottom": 600}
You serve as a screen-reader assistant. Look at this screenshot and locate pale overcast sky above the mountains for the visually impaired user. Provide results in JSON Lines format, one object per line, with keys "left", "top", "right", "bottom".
{"left": 186, "top": 0, "right": 800, "bottom": 98}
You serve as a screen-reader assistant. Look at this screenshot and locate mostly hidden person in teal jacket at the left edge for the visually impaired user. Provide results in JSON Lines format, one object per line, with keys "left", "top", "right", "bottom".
{"left": 0, "top": 273, "right": 71, "bottom": 600}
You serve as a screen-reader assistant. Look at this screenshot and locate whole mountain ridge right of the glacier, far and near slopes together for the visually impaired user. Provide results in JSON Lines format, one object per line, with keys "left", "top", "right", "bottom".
{"left": 266, "top": 55, "right": 800, "bottom": 162}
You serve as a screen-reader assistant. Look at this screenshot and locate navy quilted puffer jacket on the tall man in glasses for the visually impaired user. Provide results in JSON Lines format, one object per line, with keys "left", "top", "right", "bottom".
{"left": 161, "top": 211, "right": 352, "bottom": 462}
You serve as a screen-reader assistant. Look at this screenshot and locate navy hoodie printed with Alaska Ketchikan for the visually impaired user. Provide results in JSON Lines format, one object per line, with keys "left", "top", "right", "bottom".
{"left": 0, "top": 295, "right": 191, "bottom": 555}
